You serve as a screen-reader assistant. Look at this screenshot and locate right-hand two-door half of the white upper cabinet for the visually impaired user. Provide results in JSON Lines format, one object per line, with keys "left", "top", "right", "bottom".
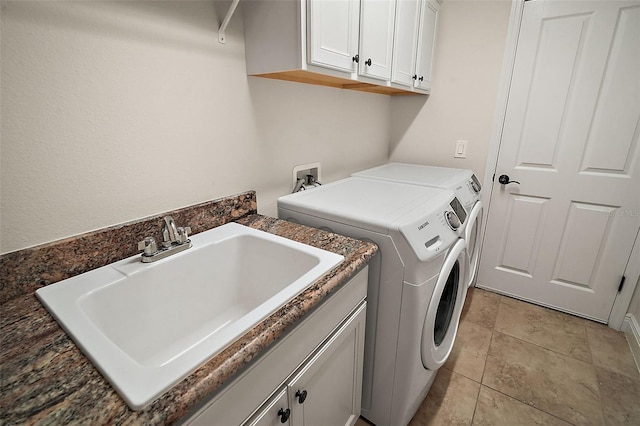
{"left": 391, "top": 0, "right": 438, "bottom": 93}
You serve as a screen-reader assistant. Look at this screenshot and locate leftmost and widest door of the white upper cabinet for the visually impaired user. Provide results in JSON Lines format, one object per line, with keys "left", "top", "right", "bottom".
{"left": 307, "top": 0, "right": 360, "bottom": 72}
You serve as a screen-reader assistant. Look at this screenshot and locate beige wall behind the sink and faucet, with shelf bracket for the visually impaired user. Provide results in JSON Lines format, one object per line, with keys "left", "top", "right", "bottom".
{"left": 0, "top": 1, "right": 390, "bottom": 253}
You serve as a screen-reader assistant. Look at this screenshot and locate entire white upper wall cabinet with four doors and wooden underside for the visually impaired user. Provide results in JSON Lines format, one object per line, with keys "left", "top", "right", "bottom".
{"left": 243, "top": 0, "right": 438, "bottom": 94}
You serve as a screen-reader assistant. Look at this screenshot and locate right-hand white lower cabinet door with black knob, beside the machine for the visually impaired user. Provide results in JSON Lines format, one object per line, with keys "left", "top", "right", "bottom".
{"left": 286, "top": 303, "right": 366, "bottom": 426}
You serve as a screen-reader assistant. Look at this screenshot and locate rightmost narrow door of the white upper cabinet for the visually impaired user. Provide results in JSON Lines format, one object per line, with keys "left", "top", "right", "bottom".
{"left": 414, "top": 0, "right": 438, "bottom": 90}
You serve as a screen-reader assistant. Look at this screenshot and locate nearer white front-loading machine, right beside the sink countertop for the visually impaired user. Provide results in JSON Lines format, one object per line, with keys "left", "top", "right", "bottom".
{"left": 278, "top": 177, "right": 468, "bottom": 426}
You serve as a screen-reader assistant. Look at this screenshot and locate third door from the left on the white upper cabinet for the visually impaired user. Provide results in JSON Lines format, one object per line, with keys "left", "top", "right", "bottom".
{"left": 391, "top": 0, "right": 420, "bottom": 87}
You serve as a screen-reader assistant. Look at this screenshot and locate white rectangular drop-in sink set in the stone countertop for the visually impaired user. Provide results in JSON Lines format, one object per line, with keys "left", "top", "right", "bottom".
{"left": 36, "top": 223, "right": 344, "bottom": 410}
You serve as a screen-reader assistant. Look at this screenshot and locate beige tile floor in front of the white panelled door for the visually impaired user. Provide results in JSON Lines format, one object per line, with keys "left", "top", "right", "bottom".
{"left": 356, "top": 289, "right": 640, "bottom": 426}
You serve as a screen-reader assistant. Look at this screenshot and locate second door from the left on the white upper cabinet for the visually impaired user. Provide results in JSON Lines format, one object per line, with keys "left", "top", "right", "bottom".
{"left": 358, "top": 0, "right": 396, "bottom": 80}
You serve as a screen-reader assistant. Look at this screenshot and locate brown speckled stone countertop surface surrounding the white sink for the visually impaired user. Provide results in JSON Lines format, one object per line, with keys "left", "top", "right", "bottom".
{"left": 0, "top": 212, "right": 377, "bottom": 425}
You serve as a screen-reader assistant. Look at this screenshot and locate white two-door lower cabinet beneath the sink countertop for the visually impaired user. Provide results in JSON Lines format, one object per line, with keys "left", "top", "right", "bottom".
{"left": 182, "top": 268, "right": 367, "bottom": 426}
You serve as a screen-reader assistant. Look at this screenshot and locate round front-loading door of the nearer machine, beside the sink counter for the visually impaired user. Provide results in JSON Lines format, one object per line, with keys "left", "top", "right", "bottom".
{"left": 421, "top": 239, "right": 468, "bottom": 370}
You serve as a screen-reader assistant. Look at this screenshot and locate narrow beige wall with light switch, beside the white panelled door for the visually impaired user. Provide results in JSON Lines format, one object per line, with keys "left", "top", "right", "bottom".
{"left": 390, "top": 0, "right": 511, "bottom": 181}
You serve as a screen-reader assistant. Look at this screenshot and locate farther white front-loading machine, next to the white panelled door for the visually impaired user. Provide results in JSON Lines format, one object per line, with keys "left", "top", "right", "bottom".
{"left": 352, "top": 163, "right": 483, "bottom": 287}
